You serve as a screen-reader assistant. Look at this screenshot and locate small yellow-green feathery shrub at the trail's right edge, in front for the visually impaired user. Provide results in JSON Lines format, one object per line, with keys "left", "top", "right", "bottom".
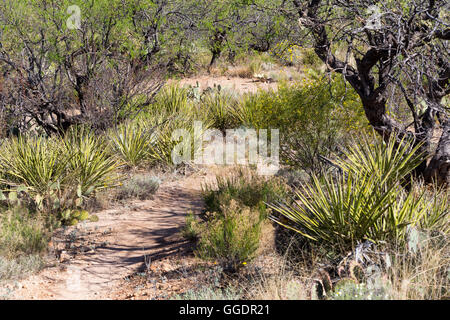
{"left": 195, "top": 201, "right": 264, "bottom": 271}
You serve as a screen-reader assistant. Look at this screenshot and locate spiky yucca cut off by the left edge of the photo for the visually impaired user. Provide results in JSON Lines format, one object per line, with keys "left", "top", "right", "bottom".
{"left": 0, "top": 136, "right": 72, "bottom": 195}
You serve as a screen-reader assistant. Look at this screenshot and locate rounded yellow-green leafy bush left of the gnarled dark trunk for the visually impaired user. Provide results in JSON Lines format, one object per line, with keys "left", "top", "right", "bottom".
{"left": 235, "top": 71, "right": 367, "bottom": 174}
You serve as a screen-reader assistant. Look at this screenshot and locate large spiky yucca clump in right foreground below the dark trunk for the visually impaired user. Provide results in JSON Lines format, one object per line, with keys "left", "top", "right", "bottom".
{"left": 270, "top": 137, "right": 445, "bottom": 248}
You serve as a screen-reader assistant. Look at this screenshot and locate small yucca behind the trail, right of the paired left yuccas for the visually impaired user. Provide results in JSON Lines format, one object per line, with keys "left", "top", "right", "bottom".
{"left": 110, "top": 121, "right": 153, "bottom": 168}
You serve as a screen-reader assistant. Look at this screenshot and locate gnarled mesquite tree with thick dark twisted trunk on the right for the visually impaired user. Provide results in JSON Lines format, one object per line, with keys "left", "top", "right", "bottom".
{"left": 292, "top": 0, "right": 450, "bottom": 184}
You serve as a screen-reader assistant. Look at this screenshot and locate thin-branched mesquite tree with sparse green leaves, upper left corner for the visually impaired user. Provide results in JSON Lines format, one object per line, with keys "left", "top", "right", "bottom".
{"left": 0, "top": 0, "right": 163, "bottom": 134}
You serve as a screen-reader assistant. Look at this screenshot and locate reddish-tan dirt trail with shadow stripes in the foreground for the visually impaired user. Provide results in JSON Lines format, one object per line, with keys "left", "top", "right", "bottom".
{"left": 13, "top": 173, "right": 211, "bottom": 300}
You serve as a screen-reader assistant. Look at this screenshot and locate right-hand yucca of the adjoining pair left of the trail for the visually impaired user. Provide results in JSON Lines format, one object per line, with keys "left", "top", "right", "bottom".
{"left": 63, "top": 127, "right": 120, "bottom": 197}
